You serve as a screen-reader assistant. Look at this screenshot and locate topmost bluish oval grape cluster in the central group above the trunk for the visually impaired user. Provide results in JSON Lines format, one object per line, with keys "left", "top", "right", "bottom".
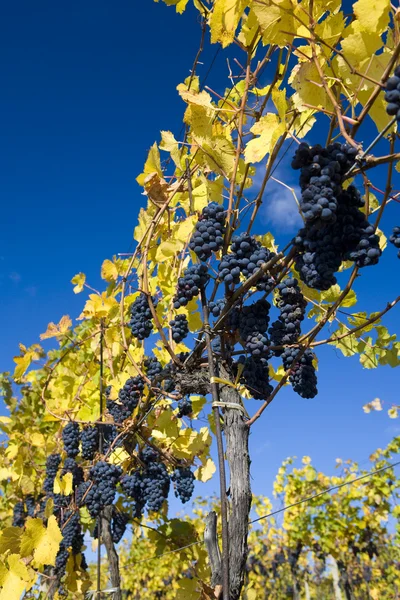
{"left": 189, "top": 202, "right": 225, "bottom": 261}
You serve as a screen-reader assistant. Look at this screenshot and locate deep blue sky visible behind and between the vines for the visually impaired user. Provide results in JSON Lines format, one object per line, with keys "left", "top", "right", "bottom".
{"left": 0, "top": 0, "right": 400, "bottom": 510}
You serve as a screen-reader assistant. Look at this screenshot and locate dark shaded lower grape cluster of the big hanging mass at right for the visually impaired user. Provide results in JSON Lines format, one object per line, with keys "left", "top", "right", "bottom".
{"left": 294, "top": 186, "right": 382, "bottom": 290}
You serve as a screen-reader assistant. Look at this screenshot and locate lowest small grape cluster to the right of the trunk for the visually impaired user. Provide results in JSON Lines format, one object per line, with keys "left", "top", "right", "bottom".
{"left": 282, "top": 348, "right": 317, "bottom": 398}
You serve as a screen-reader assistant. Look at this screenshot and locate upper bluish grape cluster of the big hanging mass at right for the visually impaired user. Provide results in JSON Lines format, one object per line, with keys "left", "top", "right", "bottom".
{"left": 292, "top": 142, "right": 357, "bottom": 223}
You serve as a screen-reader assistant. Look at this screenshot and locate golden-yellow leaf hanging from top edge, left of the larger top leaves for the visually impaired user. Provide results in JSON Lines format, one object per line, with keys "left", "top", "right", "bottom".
{"left": 210, "top": 0, "right": 246, "bottom": 48}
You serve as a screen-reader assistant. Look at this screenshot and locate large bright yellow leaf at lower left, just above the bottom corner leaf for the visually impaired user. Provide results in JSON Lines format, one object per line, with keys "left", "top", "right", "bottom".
{"left": 21, "top": 515, "right": 63, "bottom": 567}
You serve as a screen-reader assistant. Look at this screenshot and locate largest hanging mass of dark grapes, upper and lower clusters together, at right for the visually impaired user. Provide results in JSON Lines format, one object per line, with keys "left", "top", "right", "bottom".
{"left": 292, "top": 142, "right": 382, "bottom": 290}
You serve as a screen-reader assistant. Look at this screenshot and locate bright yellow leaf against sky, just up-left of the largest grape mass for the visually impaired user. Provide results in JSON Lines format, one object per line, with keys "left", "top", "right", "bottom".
{"left": 244, "top": 113, "right": 285, "bottom": 163}
